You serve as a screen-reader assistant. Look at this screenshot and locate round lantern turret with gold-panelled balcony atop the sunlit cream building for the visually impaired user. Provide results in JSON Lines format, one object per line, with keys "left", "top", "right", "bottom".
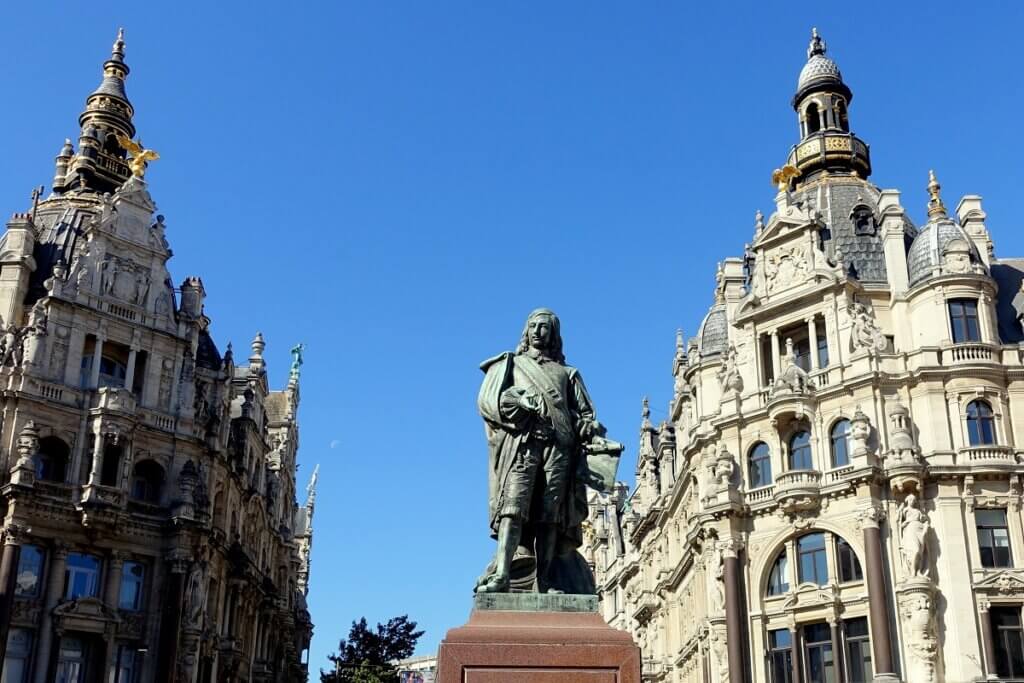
{"left": 787, "top": 29, "right": 871, "bottom": 180}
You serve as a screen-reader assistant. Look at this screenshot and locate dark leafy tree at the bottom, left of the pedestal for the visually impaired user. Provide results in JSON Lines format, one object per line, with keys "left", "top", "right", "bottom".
{"left": 321, "top": 614, "right": 423, "bottom": 683}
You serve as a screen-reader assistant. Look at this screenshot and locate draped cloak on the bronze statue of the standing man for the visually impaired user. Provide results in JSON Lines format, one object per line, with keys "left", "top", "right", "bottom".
{"left": 477, "top": 353, "right": 594, "bottom": 549}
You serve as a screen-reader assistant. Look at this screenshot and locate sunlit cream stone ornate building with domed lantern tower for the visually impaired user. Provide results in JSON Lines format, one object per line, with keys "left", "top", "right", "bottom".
{"left": 588, "top": 33, "right": 1024, "bottom": 683}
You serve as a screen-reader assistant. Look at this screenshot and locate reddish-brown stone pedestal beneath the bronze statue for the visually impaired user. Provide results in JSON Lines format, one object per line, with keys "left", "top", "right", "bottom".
{"left": 437, "top": 593, "right": 640, "bottom": 683}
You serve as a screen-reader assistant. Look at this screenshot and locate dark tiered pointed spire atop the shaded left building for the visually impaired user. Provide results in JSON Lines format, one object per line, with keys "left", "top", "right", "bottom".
{"left": 53, "top": 29, "right": 135, "bottom": 194}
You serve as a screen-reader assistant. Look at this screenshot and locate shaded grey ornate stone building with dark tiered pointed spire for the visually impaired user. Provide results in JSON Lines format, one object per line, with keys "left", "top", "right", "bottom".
{"left": 0, "top": 35, "right": 315, "bottom": 683}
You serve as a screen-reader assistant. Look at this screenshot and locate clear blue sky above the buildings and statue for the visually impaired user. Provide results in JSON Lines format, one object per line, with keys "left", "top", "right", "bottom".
{"left": 0, "top": 0, "right": 1024, "bottom": 674}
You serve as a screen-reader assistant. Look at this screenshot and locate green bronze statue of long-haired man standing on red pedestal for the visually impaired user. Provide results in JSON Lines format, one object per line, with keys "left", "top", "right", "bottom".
{"left": 476, "top": 308, "right": 623, "bottom": 594}
